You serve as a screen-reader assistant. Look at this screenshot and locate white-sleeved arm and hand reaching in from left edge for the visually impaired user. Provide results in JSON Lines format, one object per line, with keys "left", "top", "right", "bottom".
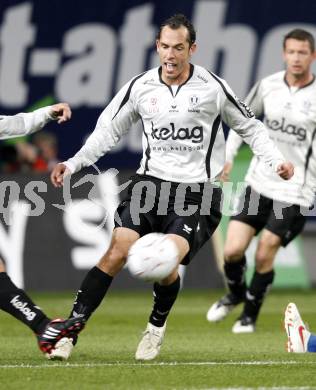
{"left": 0, "top": 103, "right": 71, "bottom": 139}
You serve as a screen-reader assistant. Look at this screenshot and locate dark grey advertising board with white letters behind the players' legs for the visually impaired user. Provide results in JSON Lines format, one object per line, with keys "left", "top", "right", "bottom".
{"left": 0, "top": 170, "right": 223, "bottom": 290}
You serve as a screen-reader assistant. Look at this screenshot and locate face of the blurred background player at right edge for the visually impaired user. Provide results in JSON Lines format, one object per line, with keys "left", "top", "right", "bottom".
{"left": 283, "top": 38, "right": 315, "bottom": 78}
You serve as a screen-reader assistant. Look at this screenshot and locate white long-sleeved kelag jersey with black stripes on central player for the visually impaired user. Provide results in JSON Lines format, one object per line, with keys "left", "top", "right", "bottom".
{"left": 65, "top": 65, "right": 284, "bottom": 183}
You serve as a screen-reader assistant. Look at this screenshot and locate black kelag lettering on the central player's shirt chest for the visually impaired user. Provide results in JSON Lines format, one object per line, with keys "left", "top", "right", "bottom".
{"left": 151, "top": 122, "right": 203, "bottom": 144}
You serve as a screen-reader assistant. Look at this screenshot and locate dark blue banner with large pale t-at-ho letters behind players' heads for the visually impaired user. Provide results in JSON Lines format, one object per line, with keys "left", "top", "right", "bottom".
{"left": 0, "top": 0, "right": 316, "bottom": 168}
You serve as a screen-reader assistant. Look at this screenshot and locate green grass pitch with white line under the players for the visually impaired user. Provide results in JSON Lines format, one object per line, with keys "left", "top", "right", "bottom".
{"left": 0, "top": 290, "right": 316, "bottom": 390}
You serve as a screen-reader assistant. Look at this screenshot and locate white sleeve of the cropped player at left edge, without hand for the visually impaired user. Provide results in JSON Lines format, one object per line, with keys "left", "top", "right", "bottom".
{"left": 0, "top": 106, "right": 53, "bottom": 140}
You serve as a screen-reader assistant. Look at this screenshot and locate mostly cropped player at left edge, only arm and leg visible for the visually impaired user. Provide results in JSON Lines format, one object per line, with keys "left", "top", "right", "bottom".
{"left": 0, "top": 103, "right": 83, "bottom": 359}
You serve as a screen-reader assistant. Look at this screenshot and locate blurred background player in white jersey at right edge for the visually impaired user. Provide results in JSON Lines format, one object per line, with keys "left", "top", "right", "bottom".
{"left": 207, "top": 29, "right": 316, "bottom": 333}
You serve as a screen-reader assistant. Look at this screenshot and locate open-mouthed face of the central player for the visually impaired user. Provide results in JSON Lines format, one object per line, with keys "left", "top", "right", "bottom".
{"left": 156, "top": 26, "right": 196, "bottom": 84}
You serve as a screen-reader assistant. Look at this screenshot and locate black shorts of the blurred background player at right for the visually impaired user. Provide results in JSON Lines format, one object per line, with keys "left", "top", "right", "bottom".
{"left": 231, "top": 186, "right": 306, "bottom": 246}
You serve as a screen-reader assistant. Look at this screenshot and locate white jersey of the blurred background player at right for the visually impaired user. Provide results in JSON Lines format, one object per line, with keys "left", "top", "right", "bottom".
{"left": 226, "top": 71, "right": 316, "bottom": 207}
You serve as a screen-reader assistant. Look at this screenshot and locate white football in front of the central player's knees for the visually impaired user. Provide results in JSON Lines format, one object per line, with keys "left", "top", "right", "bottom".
{"left": 127, "top": 233, "right": 179, "bottom": 281}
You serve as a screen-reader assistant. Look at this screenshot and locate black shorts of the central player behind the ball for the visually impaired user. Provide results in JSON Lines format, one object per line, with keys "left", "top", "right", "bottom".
{"left": 115, "top": 175, "right": 222, "bottom": 264}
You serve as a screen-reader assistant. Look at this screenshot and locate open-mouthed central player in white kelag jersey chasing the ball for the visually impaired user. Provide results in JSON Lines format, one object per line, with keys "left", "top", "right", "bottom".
{"left": 51, "top": 15, "right": 293, "bottom": 360}
